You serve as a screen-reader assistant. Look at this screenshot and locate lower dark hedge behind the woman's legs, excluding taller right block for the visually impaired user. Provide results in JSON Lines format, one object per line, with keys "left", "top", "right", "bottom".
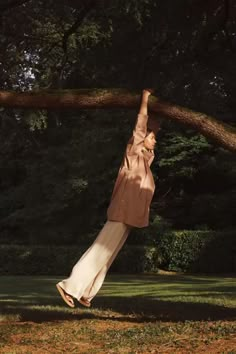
{"left": 0, "top": 245, "right": 158, "bottom": 275}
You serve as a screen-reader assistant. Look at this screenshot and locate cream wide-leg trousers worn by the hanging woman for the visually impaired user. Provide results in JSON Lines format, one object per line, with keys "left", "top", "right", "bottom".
{"left": 59, "top": 221, "right": 131, "bottom": 301}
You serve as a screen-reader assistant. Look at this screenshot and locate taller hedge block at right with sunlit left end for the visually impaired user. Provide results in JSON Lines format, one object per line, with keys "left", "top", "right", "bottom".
{"left": 157, "top": 230, "right": 236, "bottom": 273}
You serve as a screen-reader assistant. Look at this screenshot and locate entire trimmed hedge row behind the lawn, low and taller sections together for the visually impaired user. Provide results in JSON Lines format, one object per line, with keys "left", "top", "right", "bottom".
{"left": 0, "top": 230, "right": 236, "bottom": 275}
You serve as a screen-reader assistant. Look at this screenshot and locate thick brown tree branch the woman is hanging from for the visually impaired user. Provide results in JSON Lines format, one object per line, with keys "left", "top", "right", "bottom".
{"left": 0, "top": 89, "right": 236, "bottom": 152}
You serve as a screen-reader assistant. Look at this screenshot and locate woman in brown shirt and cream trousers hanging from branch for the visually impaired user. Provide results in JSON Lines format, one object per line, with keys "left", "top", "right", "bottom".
{"left": 56, "top": 90, "right": 158, "bottom": 307}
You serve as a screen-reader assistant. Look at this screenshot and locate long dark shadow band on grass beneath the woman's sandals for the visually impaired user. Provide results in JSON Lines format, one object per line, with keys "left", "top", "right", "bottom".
{"left": 0, "top": 296, "right": 236, "bottom": 323}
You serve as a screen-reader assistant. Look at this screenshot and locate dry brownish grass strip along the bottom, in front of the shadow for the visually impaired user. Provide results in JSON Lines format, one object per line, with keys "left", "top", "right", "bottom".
{"left": 0, "top": 316, "right": 236, "bottom": 354}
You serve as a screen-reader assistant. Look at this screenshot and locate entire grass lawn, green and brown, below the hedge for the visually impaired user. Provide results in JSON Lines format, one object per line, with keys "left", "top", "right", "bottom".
{"left": 0, "top": 274, "right": 236, "bottom": 354}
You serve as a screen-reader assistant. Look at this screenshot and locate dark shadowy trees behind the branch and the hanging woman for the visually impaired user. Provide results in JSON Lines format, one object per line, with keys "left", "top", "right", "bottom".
{"left": 0, "top": 0, "right": 236, "bottom": 244}
